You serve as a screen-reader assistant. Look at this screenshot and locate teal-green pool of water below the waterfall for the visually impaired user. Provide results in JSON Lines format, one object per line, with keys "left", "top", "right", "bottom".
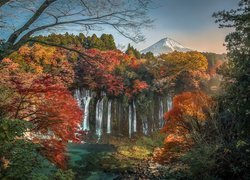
{"left": 67, "top": 143, "right": 118, "bottom": 180}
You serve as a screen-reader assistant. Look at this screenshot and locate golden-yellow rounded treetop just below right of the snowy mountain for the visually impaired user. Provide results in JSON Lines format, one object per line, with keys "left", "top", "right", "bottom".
{"left": 147, "top": 51, "right": 209, "bottom": 94}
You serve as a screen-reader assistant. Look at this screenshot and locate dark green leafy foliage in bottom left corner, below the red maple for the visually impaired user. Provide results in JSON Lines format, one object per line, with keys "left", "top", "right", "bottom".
{"left": 0, "top": 119, "right": 74, "bottom": 180}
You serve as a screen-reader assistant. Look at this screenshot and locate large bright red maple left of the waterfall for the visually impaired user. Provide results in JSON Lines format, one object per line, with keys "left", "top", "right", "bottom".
{"left": 0, "top": 59, "right": 82, "bottom": 167}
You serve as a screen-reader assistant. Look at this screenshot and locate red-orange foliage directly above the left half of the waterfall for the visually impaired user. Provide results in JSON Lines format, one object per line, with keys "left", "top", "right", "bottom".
{"left": 77, "top": 49, "right": 148, "bottom": 97}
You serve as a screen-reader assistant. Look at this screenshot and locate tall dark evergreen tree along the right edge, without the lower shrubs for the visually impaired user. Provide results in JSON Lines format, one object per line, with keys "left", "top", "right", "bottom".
{"left": 214, "top": 0, "right": 250, "bottom": 139}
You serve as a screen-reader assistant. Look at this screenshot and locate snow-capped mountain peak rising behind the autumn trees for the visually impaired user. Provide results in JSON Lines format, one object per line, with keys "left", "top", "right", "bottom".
{"left": 141, "top": 37, "right": 192, "bottom": 56}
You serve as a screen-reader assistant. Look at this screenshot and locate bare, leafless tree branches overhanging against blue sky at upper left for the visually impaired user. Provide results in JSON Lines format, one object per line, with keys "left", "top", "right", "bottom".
{"left": 0, "top": 0, "right": 151, "bottom": 59}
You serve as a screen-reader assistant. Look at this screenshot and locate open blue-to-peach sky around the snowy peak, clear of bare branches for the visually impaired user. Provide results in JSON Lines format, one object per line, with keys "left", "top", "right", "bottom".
{"left": 0, "top": 0, "right": 238, "bottom": 53}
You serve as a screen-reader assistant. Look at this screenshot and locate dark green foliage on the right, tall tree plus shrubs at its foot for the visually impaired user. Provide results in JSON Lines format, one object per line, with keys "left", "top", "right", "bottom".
{"left": 168, "top": 0, "right": 250, "bottom": 179}
